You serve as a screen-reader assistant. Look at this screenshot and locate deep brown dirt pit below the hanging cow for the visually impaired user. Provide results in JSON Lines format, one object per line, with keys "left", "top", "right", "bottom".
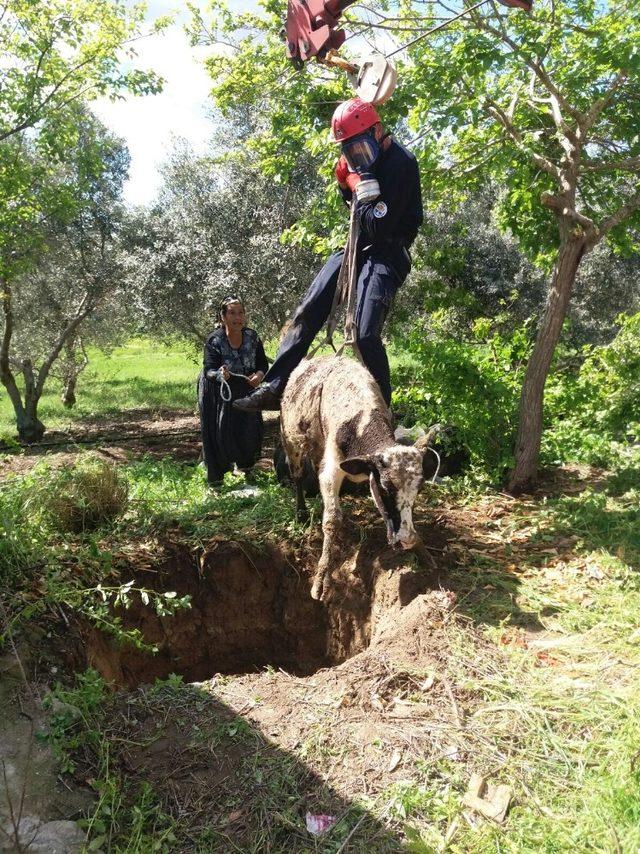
{"left": 76, "top": 538, "right": 444, "bottom": 688}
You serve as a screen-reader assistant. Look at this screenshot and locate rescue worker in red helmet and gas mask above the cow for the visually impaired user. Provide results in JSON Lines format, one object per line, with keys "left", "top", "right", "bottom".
{"left": 233, "top": 98, "right": 423, "bottom": 412}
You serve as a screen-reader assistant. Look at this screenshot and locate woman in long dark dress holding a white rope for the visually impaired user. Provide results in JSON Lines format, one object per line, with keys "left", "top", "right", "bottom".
{"left": 198, "top": 297, "right": 268, "bottom": 486}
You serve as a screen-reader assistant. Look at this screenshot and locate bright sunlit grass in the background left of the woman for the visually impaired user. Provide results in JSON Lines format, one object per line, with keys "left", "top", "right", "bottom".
{"left": 0, "top": 338, "right": 201, "bottom": 436}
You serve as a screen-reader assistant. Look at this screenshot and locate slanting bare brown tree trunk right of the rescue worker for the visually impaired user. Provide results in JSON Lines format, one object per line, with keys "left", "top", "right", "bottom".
{"left": 509, "top": 232, "right": 587, "bottom": 493}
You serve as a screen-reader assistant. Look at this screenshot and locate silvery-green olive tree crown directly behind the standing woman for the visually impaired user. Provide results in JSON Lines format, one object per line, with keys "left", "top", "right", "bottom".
{"left": 126, "top": 136, "right": 317, "bottom": 346}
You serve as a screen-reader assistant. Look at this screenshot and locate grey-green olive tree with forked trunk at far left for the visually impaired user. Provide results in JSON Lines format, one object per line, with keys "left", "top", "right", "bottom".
{"left": 0, "top": 110, "right": 129, "bottom": 442}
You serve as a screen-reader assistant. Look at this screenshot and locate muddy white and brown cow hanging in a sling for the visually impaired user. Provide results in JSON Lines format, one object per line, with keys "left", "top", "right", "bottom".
{"left": 281, "top": 356, "right": 424, "bottom": 599}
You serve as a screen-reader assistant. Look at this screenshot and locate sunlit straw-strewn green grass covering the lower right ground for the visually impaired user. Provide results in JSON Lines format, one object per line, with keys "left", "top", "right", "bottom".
{"left": 392, "top": 459, "right": 640, "bottom": 854}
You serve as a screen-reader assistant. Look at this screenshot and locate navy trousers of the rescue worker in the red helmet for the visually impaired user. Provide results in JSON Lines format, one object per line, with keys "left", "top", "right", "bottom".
{"left": 265, "top": 251, "right": 410, "bottom": 405}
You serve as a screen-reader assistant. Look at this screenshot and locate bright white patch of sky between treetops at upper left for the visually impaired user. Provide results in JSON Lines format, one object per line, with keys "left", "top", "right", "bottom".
{"left": 93, "top": 0, "right": 251, "bottom": 204}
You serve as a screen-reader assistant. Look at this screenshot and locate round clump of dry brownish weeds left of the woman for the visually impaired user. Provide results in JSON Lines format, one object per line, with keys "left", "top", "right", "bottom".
{"left": 48, "top": 456, "right": 128, "bottom": 533}
